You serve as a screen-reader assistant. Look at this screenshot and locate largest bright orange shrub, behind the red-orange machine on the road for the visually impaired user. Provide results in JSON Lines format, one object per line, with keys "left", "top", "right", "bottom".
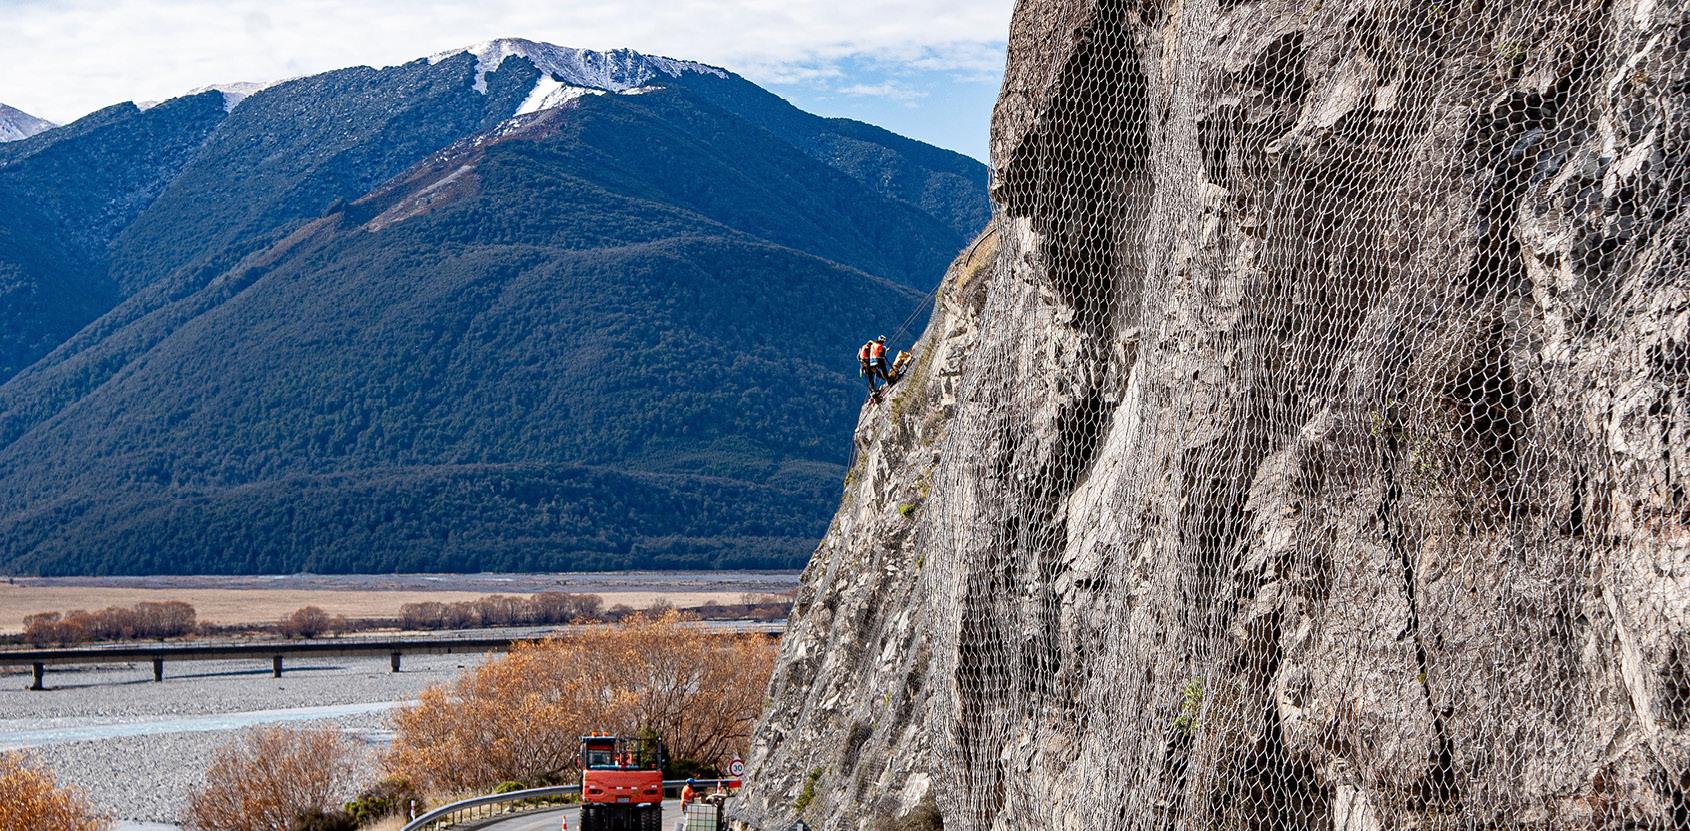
{"left": 384, "top": 611, "right": 774, "bottom": 792}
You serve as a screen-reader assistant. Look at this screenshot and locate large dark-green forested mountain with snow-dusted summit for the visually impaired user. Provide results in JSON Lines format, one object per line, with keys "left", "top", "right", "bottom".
{"left": 0, "top": 42, "right": 987, "bottom": 573}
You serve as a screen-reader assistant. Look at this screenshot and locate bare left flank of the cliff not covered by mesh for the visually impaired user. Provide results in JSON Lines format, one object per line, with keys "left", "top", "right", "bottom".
{"left": 737, "top": 228, "right": 997, "bottom": 828}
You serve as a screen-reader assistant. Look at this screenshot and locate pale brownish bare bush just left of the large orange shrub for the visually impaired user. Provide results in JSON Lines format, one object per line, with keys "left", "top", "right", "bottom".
{"left": 186, "top": 728, "right": 360, "bottom": 831}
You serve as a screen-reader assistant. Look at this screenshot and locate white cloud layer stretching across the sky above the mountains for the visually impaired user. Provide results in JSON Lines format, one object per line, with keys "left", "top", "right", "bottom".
{"left": 0, "top": 0, "right": 1012, "bottom": 122}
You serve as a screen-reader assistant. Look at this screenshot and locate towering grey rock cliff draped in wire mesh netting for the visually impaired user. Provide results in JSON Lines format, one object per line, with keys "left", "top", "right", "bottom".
{"left": 740, "top": 0, "right": 1690, "bottom": 831}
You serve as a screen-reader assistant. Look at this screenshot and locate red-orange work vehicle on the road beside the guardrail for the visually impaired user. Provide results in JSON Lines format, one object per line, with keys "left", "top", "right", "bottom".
{"left": 580, "top": 735, "right": 664, "bottom": 831}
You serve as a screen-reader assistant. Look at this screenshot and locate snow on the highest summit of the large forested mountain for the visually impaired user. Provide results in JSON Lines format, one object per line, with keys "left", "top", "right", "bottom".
{"left": 428, "top": 37, "right": 728, "bottom": 93}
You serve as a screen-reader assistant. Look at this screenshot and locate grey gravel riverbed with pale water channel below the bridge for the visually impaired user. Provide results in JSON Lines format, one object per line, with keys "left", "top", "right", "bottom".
{"left": 0, "top": 655, "right": 480, "bottom": 828}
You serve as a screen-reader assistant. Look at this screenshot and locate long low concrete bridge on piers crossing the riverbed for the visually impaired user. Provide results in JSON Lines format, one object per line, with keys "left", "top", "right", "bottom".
{"left": 0, "top": 622, "right": 786, "bottom": 689}
